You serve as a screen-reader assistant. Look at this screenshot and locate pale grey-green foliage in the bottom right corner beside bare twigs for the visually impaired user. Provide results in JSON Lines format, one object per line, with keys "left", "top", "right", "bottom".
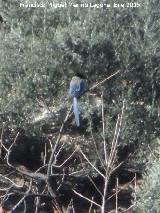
{"left": 135, "top": 138, "right": 160, "bottom": 213}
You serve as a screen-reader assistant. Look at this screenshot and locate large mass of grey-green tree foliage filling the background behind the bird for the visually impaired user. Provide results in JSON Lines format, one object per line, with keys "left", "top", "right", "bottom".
{"left": 0, "top": 0, "right": 160, "bottom": 150}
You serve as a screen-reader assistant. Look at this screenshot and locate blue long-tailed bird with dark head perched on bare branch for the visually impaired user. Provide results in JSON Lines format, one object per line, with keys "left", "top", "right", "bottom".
{"left": 69, "top": 76, "right": 86, "bottom": 127}
